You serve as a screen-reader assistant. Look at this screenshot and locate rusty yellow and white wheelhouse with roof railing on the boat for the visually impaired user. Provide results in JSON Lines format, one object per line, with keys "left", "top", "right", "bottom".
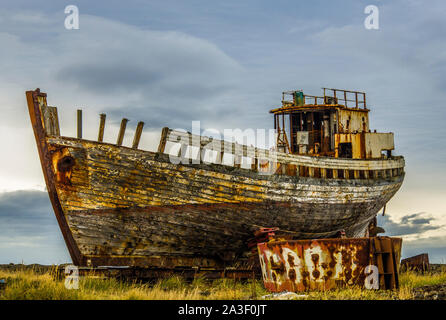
{"left": 270, "top": 88, "right": 394, "bottom": 159}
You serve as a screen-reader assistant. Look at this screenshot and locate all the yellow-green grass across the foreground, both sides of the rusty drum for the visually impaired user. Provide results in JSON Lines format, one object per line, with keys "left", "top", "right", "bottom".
{"left": 0, "top": 269, "right": 446, "bottom": 300}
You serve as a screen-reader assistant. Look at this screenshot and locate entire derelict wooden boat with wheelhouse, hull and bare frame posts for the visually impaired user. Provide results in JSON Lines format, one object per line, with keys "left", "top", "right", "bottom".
{"left": 26, "top": 89, "right": 404, "bottom": 268}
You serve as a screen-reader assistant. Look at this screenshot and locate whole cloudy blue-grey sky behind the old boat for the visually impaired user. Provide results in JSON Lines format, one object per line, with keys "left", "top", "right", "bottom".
{"left": 0, "top": 0, "right": 446, "bottom": 264}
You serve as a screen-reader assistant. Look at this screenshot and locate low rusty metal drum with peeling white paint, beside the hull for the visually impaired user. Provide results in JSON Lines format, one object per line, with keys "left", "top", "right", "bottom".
{"left": 258, "top": 237, "right": 402, "bottom": 292}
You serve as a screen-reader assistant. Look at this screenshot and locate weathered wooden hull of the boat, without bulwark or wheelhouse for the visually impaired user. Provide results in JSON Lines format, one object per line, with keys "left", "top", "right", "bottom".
{"left": 27, "top": 92, "right": 404, "bottom": 268}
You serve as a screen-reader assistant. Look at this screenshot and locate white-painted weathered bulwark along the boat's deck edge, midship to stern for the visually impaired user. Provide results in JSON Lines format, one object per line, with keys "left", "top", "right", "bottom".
{"left": 158, "top": 127, "right": 404, "bottom": 179}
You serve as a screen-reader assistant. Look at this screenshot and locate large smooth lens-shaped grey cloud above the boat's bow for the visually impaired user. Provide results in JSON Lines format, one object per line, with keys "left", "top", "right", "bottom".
{"left": 0, "top": 13, "right": 243, "bottom": 128}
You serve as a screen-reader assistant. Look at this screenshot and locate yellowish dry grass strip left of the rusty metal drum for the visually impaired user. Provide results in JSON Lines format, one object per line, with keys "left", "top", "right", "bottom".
{"left": 0, "top": 270, "right": 268, "bottom": 300}
